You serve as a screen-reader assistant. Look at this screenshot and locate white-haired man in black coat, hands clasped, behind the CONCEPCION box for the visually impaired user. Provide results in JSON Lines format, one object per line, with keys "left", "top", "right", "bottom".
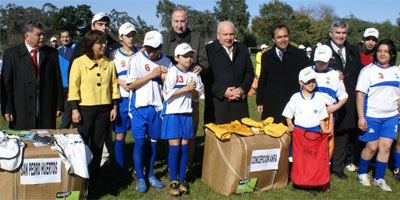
{"left": 204, "top": 21, "right": 254, "bottom": 124}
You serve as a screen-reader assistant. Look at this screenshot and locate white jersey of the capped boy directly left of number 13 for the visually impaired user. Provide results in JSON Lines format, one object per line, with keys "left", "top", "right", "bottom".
{"left": 126, "top": 52, "right": 172, "bottom": 111}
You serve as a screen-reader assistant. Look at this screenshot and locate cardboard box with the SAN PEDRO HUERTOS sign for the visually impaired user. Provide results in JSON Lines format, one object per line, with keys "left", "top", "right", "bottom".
{"left": 0, "top": 129, "right": 86, "bottom": 199}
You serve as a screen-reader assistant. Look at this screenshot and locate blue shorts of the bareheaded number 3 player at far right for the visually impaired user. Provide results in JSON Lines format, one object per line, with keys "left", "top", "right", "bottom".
{"left": 358, "top": 115, "right": 399, "bottom": 142}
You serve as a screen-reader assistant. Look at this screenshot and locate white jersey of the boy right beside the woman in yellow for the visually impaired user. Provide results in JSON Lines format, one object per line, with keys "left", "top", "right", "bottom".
{"left": 110, "top": 48, "right": 139, "bottom": 97}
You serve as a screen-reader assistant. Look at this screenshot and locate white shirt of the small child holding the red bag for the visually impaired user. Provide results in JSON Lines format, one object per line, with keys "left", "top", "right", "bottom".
{"left": 282, "top": 92, "right": 328, "bottom": 128}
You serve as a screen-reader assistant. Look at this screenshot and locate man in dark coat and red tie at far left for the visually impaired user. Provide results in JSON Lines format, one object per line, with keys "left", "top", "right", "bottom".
{"left": 1, "top": 22, "right": 63, "bottom": 130}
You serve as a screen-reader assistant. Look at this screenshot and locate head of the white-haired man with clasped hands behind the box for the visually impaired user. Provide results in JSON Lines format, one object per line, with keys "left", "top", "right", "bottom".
{"left": 217, "top": 21, "right": 235, "bottom": 48}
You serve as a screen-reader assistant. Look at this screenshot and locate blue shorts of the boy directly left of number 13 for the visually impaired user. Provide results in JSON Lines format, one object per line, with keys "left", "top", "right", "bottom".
{"left": 131, "top": 106, "right": 161, "bottom": 139}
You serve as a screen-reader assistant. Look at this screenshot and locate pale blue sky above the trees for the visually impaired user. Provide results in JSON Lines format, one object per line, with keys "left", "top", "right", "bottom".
{"left": 0, "top": 0, "right": 400, "bottom": 28}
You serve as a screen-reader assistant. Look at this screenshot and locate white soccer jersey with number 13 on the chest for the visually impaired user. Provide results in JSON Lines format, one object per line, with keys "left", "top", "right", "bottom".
{"left": 162, "top": 65, "right": 203, "bottom": 114}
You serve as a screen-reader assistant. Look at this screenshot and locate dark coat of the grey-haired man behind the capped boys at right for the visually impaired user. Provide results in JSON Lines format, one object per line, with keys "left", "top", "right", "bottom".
{"left": 326, "top": 40, "right": 363, "bottom": 131}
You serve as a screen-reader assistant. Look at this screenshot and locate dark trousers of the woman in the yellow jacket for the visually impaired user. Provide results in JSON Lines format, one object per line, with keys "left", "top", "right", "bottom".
{"left": 74, "top": 105, "right": 112, "bottom": 181}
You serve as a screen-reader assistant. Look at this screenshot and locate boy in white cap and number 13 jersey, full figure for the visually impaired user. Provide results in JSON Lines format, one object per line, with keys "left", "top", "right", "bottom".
{"left": 161, "top": 43, "right": 203, "bottom": 196}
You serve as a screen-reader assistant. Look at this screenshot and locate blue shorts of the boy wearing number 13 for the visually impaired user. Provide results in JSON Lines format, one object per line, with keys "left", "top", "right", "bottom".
{"left": 161, "top": 113, "right": 193, "bottom": 140}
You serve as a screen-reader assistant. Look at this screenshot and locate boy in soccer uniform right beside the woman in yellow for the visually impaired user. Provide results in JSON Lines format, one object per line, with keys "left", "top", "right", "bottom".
{"left": 111, "top": 22, "right": 138, "bottom": 181}
